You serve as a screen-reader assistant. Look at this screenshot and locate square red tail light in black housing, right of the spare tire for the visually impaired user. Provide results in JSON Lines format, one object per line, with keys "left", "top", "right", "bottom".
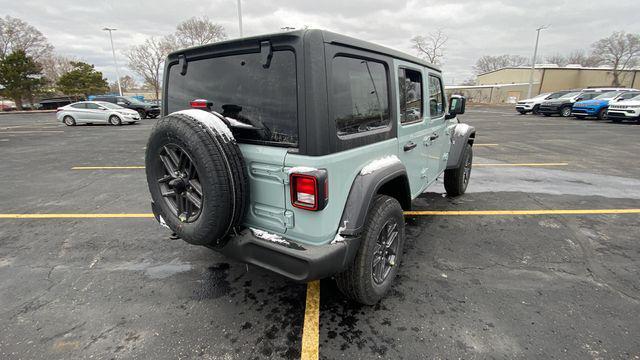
{"left": 289, "top": 170, "right": 329, "bottom": 211}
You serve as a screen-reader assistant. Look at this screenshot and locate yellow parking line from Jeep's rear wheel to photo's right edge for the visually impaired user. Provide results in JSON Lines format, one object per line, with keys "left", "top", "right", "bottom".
{"left": 404, "top": 209, "right": 640, "bottom": 216}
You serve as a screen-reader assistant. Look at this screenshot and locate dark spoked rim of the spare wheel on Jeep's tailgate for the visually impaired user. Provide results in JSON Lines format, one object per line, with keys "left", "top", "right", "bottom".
{"left": 158, "top": 144, "right": 204, "bottom": 223}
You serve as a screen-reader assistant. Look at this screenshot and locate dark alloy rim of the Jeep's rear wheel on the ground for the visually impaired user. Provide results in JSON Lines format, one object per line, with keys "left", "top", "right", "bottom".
{"left": 371, "top": 219, "right": 398, "bottom": 285}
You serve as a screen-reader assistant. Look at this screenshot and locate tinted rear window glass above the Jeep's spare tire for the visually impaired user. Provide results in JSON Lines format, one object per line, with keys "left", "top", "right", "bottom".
{"left": 167, "top": 51, "right": 298, "bottom": 146}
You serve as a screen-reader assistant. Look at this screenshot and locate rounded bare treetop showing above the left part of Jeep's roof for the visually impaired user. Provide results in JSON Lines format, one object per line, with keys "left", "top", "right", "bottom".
{"left": 175, "top": 16, "right": 227, "bottom": 47}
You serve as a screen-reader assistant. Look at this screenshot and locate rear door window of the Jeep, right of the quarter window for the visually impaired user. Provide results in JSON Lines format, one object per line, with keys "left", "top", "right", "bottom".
{"left": 398, "top": 69, "right": 424, "bottom": 124}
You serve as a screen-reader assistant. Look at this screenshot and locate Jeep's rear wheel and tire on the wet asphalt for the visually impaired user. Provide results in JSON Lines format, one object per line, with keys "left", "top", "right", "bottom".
{"left": 336, "top": 195, "right": 405, "bottom": 305}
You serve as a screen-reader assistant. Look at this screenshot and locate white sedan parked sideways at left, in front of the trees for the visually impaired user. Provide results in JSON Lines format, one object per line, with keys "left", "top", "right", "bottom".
{"left": 56, "top": 101, "right": 140, "bottom": 126}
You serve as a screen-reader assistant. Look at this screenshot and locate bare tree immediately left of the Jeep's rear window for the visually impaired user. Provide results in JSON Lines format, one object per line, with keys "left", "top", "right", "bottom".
{"left": 125, "top": 36, "right": 176, "bottom": 99}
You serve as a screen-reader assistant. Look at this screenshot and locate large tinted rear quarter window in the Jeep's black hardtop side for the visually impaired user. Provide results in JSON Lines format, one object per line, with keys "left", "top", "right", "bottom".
{"left": 331, "top": 56, "right": 391, "bottom": 136}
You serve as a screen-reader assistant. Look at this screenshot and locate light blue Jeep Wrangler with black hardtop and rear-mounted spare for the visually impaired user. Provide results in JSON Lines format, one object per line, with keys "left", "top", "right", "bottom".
{"left": 146, "top": 30, "right": 475, "bottom": 304}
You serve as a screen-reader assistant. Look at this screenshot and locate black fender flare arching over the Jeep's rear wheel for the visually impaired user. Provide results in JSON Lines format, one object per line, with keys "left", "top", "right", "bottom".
{"left": 338, "top": 162, "right": 411, "bottom": 236}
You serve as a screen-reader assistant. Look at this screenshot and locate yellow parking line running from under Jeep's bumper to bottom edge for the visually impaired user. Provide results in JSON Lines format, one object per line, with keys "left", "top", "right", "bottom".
{"left": 300, "top": 280, "right": 320, "bottom": 360}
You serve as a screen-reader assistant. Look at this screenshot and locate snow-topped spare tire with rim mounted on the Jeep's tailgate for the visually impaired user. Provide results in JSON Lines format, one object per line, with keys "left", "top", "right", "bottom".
{"left": 145, "top": 110, "right": 249, "bottom": 247}
